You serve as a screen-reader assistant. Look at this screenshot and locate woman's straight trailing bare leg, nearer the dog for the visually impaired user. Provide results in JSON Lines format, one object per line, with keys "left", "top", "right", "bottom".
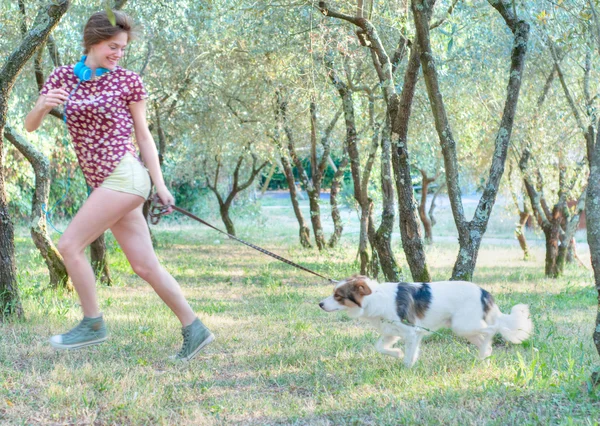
{"left": 110, "top": 205, "right": 196, "bottom": 327}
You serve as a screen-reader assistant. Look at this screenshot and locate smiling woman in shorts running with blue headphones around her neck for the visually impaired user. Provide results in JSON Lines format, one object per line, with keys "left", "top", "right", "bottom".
{"left": 25, "top": 11, "right": 214, "bottom": 360}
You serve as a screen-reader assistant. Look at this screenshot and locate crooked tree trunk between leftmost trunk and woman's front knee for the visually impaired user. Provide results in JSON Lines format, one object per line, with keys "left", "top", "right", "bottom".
{"left": 4, "top": 126, "right": 73, "bottom": 291}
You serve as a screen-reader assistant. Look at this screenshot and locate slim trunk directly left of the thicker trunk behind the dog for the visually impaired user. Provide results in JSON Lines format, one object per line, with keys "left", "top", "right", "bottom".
{"left": 372, "top": 117, "right": 402, "bottom": 282}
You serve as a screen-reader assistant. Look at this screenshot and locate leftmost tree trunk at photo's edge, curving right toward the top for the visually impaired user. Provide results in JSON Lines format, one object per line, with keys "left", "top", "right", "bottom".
{"left": 0, "top": 0, "right": 70, "bottom": 319}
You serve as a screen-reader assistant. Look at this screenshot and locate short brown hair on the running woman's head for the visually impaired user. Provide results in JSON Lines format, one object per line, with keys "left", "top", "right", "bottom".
{"left": 83, "top": 10, "right": 137, "bottom": 55}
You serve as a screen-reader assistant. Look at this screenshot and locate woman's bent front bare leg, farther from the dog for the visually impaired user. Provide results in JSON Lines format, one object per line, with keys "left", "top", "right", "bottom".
{"left": 58, "top": 188, "right": 144, "bottom": 317}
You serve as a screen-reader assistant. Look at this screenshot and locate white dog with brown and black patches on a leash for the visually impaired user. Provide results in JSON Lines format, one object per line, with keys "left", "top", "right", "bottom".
{"left": 319, "top": 275, "right": 533, "bottom": 368}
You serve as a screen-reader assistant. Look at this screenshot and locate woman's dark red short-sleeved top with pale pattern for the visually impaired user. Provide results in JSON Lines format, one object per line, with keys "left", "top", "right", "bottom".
{"left": 40, "top": 65, "right": 148, "bottom": 188}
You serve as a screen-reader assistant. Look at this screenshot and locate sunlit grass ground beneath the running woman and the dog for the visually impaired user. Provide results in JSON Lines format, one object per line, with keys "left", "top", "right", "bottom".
{"left": 0, "top": 195, "right": 600, "bottom": 425}
